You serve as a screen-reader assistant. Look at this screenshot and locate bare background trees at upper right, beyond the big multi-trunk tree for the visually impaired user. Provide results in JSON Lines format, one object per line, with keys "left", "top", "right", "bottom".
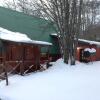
{"left": 82, "top": 0, "right": 100, "bottom": 32}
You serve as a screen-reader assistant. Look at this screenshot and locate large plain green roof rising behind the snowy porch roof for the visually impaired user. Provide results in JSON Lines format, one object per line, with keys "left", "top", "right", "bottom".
{"left": 0, "top": 7, "right": 57, "bottom": 53}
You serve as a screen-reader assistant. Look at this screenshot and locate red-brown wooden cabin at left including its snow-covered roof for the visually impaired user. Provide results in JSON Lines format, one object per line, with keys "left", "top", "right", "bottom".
{"left": 0, "top": 29, "right": 52, "bottom": 75}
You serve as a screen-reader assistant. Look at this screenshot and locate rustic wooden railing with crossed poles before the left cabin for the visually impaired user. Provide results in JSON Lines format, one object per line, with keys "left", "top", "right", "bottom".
{"left": 0, "top": 60, "right": 49, "bottom": 85}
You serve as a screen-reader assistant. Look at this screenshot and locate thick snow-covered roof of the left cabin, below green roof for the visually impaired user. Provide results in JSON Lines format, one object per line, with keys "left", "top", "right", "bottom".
{"left": 0, "top": 27, "right": 52, "bottom": 45}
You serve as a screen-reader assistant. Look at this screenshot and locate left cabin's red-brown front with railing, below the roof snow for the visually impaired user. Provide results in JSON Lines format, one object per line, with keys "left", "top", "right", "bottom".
{"left": 0, "top": 39, "right": 51, "bottom": 85}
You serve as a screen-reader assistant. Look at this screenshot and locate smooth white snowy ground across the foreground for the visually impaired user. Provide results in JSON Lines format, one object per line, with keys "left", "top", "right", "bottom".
{"left": 0, "top": 60, "right": 100, "bottom": 100}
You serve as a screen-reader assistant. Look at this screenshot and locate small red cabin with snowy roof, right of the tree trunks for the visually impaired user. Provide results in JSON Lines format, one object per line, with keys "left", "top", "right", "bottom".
{"left": 77, "top": 39, "right": 100, "bottom": 62}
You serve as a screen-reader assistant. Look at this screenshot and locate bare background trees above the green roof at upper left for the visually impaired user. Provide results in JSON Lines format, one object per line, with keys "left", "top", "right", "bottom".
{"left": 4, "top": 0, "right": 42, "bottom": 17}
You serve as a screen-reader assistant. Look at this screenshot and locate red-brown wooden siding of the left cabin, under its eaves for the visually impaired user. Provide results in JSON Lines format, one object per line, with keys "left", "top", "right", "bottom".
{"left": 0, "top": 41, "right": 51, "bottom": 74}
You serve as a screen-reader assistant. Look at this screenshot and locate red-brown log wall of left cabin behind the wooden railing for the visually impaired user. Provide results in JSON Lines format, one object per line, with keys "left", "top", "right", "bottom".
{"left": 0, "top": 42, "right": 40, "bottom": 72}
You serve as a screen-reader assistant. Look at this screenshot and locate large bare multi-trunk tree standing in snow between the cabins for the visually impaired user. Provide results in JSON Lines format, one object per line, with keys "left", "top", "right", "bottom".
{"left": 34, "top": 0, "right": 83, "bottom": 65}
